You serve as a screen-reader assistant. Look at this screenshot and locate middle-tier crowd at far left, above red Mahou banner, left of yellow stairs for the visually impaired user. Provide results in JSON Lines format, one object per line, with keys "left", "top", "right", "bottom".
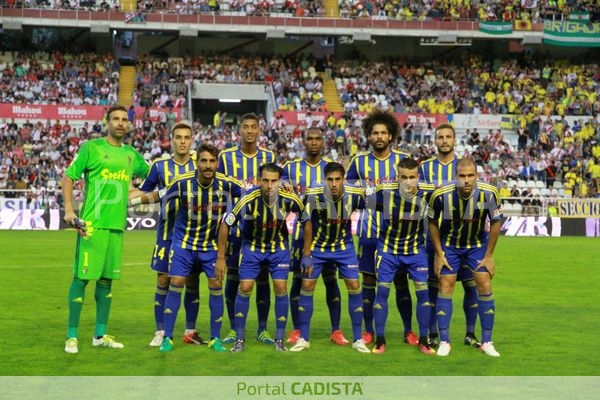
{"left": 0, "top": 51, "right": 120, "bottom": 106}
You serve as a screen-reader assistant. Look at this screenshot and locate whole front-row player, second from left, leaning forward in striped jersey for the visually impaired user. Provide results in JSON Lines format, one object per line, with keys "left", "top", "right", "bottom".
{"left": 216, "top": 163, "right": 304, "bottom": 353}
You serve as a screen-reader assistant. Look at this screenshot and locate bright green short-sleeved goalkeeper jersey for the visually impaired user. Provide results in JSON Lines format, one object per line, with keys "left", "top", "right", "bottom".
{"left": 65, "top": 138, "right": 149, "bottom": 231}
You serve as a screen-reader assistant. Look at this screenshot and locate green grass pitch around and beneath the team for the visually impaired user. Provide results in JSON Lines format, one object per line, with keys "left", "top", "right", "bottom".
{"left": 0, "top": 231, "right": 600, "bottom": 376}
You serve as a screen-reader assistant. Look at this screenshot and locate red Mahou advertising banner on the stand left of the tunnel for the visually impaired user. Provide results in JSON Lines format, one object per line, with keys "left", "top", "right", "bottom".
{"left": 0, "top": 103, "right": 181, "bottom": 122}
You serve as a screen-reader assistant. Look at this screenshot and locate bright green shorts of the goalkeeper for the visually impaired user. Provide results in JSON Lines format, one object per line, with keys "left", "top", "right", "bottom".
{"left": 73, "top": 229, "right": 123, "bottom": 280}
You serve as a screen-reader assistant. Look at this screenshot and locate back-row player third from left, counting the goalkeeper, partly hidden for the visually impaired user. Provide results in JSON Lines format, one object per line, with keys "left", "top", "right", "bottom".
{"left": 217, "top": 114, "right": 275, "bottom": 344}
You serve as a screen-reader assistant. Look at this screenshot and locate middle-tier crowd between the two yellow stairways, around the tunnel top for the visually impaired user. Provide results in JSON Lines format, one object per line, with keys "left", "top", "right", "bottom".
{"left": 133, "top": 54, "right": 326, "bottom": 111}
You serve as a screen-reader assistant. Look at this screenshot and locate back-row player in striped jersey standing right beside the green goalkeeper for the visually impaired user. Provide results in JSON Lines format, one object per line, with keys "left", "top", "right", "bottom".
{"left": 134, "top": 122, "right": 205, "bottom": 347}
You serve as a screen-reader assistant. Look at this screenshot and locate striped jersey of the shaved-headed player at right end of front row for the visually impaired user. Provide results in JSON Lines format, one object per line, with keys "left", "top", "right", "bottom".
{"left": 429, "top": 181, "right": 502, "bottom": 249}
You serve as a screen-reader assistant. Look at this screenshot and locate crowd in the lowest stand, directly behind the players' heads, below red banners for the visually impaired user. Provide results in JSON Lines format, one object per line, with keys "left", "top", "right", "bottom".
{"left": 0, "top": 102, "right": 600, "bottom": 213}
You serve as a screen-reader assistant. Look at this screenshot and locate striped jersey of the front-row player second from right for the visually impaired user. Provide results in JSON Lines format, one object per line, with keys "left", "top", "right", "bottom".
{"left": 374, "top": 182, "right": 435, "bottom": 255}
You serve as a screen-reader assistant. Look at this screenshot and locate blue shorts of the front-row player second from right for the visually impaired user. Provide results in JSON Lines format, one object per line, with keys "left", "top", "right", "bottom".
{"left": 376, "top": 249, "right": 429, "bottom": 283}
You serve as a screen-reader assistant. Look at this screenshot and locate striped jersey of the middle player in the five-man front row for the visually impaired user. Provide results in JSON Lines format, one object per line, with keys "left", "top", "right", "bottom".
{"left": 304, "top": 186, "right": 365, "bottom": 253}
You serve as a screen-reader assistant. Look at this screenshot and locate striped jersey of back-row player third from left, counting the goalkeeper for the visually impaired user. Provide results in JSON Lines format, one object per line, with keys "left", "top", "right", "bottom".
{"left": 217, "top": 146, "right": 275, "bottom": 238}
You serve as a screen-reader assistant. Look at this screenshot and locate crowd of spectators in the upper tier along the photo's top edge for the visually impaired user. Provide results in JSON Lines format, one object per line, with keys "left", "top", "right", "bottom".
{"left": 0, "top": 0, "right": 600, "bottom": 23}
